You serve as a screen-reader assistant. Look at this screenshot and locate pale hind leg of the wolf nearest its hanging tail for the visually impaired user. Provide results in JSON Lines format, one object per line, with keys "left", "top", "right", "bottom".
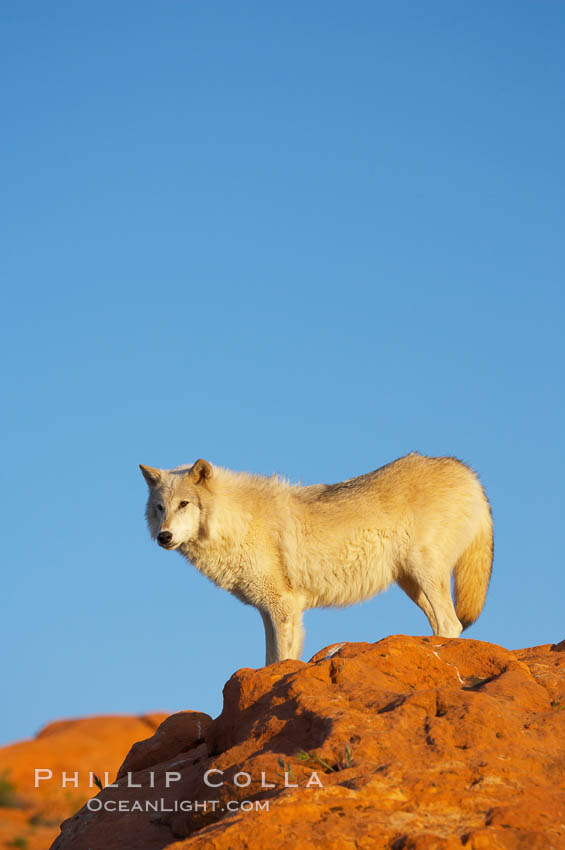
{"left": 408, "top": 548, "right": 463, "bottom": 637}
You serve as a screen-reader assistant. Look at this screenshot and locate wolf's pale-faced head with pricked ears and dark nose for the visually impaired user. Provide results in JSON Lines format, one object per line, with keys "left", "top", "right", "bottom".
{"left": 139, "top": 460, "right": 213, "bottom": 549}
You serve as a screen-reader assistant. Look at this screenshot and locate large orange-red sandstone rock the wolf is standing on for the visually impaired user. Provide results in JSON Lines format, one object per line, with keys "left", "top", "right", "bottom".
{"left": 49, "top": 636, "right": 565, "bottom": 850}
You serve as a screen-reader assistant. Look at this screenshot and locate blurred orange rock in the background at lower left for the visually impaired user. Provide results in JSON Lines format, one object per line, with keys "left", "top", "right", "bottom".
{"left": 0, "top": 713, "right": 167, "bottom": 850}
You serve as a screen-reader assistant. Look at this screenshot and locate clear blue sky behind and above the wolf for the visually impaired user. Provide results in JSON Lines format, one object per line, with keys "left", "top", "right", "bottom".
{"left": 0, "top": 0, "right": 565, "bottom": 741}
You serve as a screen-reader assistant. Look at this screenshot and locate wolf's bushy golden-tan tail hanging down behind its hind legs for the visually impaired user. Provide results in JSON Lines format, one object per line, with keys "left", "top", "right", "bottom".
{"left": 455, "top": 507, "right": 494, "bottom": 629}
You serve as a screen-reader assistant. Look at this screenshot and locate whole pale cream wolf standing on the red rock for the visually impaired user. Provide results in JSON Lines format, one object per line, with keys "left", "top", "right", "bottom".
{"left": 141, "top": 453, "right": 493, "bottom": 664}
